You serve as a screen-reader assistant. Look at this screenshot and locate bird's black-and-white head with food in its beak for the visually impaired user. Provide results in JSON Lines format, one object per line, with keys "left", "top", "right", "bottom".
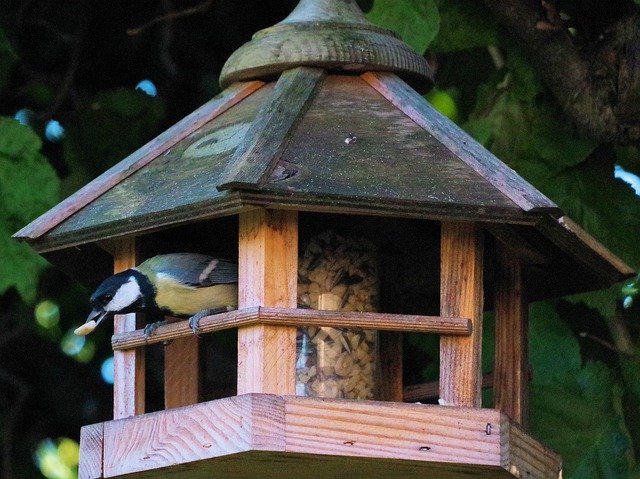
{"left": 76, "top": 269, "right": 155, "bottom": 334}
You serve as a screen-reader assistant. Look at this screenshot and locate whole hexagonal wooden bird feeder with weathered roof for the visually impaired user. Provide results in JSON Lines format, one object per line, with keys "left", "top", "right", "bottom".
{"left": 16, "top": 0, "right": 632, "bottom": 479}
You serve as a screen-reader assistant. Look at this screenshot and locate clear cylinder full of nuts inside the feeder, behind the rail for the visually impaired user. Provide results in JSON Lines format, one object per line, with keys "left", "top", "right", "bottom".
{"left": 296, "top": 231, "right": 379, "bottom": 399}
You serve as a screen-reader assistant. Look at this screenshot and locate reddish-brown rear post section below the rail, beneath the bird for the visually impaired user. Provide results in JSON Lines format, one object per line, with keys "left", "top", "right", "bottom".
{"left": 164, "top": 334, "right": 200, "bottom": 409}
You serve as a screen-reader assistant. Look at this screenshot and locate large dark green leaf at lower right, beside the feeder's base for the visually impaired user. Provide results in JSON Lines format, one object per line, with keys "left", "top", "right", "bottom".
{"left": 530, "top": 302, "right": 633, "bottom": 479}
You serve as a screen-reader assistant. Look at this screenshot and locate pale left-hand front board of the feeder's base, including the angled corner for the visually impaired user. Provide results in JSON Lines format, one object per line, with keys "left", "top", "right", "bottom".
{"left": 104, "top": 395, "right": 284, "bottom": 477}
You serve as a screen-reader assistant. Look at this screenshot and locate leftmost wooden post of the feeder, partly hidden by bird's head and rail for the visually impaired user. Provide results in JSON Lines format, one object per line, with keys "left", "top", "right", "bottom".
{"left": 111, "top": 237, "right": 145, "bottom": 419}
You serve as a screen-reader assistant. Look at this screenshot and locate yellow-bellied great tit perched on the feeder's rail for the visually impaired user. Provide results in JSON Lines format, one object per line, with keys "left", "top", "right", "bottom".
{"left": 75, "top": 253, "right": 238, "bottom": 336}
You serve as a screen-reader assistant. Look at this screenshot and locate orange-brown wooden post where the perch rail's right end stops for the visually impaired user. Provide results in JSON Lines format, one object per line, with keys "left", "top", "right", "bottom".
{"left": 440, "top": 222, "right": 484, "bottom": 407}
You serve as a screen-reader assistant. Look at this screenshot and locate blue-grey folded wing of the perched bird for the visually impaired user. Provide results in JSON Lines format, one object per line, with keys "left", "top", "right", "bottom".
{"left": 138, "top": 253, "right": 238, "bottom": 288}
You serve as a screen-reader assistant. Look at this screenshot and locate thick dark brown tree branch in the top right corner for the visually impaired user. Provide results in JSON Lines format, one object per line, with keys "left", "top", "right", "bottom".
{"left": 485, "top": 0, "right": 640, "bottom": 144}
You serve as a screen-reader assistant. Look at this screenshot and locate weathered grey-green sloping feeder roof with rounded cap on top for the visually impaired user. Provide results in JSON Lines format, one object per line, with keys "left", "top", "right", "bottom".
{"left": 15, "top": 0, "right": 632, "bottom": 295}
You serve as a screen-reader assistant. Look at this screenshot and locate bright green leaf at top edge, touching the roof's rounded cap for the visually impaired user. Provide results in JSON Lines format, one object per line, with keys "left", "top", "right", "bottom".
{"left": 367, "top": 0, "right": 440, "bottom": 54}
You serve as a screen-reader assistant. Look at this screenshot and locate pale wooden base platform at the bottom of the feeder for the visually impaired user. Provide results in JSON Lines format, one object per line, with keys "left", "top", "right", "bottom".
{"left": 80, "top": 394, "right": 561, "bottom": 479}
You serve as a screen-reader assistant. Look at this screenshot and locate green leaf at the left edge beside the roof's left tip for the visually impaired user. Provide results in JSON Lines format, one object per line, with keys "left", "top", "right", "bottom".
{"left": 0, "top": 117, "right": 60, "bottom": 302}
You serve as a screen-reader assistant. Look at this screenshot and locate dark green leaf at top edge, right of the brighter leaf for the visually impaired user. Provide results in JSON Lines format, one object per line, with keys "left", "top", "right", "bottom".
{"left": 430, "top": 0, "right": 499, "bottom": 53}
